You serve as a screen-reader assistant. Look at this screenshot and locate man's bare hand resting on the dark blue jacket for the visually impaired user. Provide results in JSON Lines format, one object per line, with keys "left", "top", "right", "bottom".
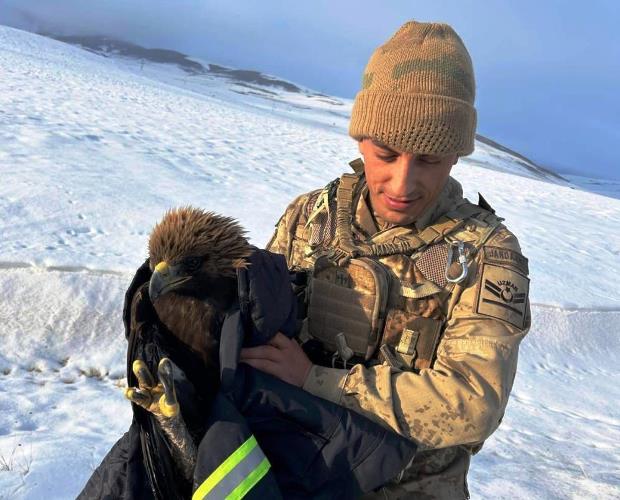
{"left": 240, "top": 332, "right": 312, "bottom": 387}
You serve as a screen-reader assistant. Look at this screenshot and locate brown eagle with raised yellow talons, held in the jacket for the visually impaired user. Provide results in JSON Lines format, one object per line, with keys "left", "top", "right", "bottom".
{"left": 125, "top": 206, "right": 253, "bottom": 488}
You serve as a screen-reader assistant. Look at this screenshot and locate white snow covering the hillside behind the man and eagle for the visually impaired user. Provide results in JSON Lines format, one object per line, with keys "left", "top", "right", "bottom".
{"left": 0, "top": 26, "right": 620, "bottom": 499}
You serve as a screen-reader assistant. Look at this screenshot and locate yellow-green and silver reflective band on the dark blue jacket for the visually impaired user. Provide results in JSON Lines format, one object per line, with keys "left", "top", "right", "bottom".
{"left": 192, "top": 436, "right": 271, "bottom": 500}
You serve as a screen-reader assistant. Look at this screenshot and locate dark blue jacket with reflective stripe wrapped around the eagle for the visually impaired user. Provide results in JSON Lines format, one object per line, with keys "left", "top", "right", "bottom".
{"left": 78, "top": 249, "right": 416, "bottom": 500}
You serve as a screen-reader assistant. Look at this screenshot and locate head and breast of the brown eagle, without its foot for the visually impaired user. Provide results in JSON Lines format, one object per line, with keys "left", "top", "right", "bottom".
{"left": 149, "top": 207, "right": 251, "bottom": 364}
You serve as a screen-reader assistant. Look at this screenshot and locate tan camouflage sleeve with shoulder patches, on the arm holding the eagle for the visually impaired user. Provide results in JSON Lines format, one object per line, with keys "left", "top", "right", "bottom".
{"left": 304, "top": 230, "right": 530, "bottom": 449}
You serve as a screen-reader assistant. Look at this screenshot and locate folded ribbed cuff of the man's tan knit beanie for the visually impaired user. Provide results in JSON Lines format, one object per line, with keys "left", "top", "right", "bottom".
{"left": 349, "top": 90, "right": 476, "bottom": 156}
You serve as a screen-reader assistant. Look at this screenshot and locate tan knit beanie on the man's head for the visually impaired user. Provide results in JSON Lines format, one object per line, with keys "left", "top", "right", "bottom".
{"left": 349, "top": 21, "right": 476, "bottom": 156}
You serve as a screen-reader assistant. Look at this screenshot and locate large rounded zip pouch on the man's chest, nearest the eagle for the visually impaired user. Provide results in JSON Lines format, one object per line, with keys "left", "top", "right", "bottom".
{"left": 308, "top": 257, "right": 389, "bottom": 360}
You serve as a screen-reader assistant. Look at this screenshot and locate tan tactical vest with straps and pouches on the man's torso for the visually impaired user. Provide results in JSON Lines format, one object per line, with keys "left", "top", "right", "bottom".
{"left": 291, "top": 166, "right": 502, "bottom": 372}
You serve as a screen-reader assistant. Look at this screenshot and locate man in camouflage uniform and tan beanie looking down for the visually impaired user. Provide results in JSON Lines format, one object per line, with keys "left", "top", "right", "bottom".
{"left": 242, "top": 22, "right": 530, "bottom": 499}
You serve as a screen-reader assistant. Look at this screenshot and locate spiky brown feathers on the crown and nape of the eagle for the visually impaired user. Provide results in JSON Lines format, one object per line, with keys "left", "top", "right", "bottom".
{"left": 149, "top": 206, "right": 252, "bottom": 276}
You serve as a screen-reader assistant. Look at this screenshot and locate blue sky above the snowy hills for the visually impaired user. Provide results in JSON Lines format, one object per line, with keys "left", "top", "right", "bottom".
{"left": 0, "top": 0, "right": 620, "bottom": 179}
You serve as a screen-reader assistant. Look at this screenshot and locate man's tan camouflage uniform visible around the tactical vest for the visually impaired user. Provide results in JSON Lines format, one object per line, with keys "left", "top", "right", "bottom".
{"left": 267, "top": 170, "right": 530, "bottom": 499}
